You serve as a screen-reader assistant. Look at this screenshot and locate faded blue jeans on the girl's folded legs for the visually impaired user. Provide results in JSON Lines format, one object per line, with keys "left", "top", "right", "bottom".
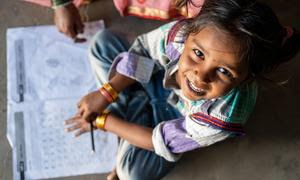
{"left": 89, "top": 30, "right": 181, "bottom": 180}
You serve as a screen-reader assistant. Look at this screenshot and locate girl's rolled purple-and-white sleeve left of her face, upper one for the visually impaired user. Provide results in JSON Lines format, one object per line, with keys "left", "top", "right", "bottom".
{"left": 109, "top": 22, "right": 175, "bottom": 83}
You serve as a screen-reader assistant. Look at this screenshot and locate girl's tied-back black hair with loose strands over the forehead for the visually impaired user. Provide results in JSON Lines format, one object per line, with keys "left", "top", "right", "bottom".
{"left": 183, "top": 0, "right": 300, "bottom": 77}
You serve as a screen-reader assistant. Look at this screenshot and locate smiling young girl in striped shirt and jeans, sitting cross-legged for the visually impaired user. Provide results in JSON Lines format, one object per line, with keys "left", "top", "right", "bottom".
{"left": 66, "top": 0, "right": 299, "bottom": 180}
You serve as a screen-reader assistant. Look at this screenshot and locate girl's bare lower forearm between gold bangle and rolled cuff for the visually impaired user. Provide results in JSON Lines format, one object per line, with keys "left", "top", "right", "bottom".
{"left": 104, "top": 114, "right": 153, "bottom": 150}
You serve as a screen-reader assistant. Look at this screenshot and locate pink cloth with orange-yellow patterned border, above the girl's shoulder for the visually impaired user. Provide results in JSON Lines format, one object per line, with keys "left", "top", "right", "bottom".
{"left": 114, "top": 0, "right": 204, "bottom": 20}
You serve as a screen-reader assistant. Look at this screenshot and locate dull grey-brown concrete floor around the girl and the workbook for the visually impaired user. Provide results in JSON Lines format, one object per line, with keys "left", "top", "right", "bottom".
{"left": 0, "top": 0, "right": 300, "bottom": 180}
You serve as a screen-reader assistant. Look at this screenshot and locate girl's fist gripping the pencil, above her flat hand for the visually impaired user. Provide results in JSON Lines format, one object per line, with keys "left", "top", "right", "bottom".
{"left": 75, "top": 90, "right": 109, "bottom": 122}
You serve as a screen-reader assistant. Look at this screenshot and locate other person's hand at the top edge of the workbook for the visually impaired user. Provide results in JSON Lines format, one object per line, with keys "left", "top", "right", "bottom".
{"left": 54, "top": 3, "right": 85, "bottom": 42}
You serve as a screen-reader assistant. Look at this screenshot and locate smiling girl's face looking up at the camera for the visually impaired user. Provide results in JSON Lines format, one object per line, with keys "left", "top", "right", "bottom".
{"left": 176, "top": 26, "right": 248, "bottom": 100}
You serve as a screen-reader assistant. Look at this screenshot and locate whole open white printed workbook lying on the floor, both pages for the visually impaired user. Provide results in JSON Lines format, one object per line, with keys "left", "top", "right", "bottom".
{"left": 7, "top": 21, "right": 117, "bottom": 179}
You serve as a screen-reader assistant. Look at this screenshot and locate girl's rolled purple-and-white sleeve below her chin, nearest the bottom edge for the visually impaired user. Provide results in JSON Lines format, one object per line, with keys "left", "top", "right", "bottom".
{"left": 152, "top": 116, "right": 231, "bottom": 161}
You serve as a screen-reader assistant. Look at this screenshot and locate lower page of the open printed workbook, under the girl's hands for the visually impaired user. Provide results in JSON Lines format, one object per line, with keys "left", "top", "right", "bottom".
{"left": 11, "top": 99, "right": 117, "bottom": 179}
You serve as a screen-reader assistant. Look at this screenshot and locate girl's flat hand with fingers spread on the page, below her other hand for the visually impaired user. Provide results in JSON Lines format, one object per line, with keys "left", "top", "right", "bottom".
{"left": 65, "top": 115, "right": 96, "bottom": 137}
